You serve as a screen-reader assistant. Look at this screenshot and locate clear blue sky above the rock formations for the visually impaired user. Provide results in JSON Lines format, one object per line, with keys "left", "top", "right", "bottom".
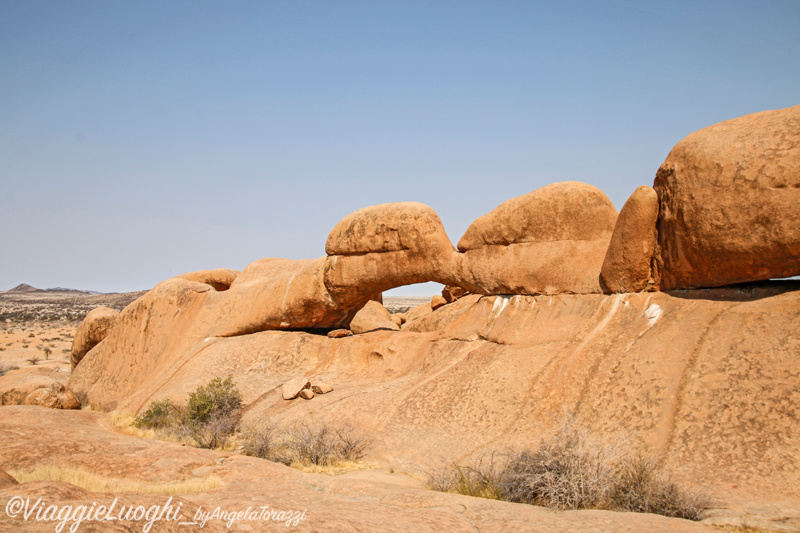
{"left": 0, "top": 0, "right": 800, "bottom": 293}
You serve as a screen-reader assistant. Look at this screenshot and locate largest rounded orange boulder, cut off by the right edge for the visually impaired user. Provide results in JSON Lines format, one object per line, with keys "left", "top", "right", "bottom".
{"left": 654, "top": 106, "right": 800, "bottom": 290}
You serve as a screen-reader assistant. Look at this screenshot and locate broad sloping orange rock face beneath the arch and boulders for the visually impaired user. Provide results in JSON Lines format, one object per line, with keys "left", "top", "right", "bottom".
{"left": 64, "top": 282, "right": 800, "bottom": 529}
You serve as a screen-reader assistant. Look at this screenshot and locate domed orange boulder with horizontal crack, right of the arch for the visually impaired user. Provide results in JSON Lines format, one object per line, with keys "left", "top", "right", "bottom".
{"left": 455, "top": 182, "right": 617, "bottom": 294}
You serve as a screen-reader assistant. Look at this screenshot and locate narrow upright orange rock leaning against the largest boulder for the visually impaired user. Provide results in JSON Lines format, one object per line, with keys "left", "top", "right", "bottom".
{"left": 600, "top": 185, "right": 658, "bottom": 293}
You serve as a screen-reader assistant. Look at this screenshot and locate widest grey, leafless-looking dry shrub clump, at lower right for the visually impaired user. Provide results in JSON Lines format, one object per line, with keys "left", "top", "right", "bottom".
{"left": 428, "top": 419, "right": 710, "bottom": 520}
